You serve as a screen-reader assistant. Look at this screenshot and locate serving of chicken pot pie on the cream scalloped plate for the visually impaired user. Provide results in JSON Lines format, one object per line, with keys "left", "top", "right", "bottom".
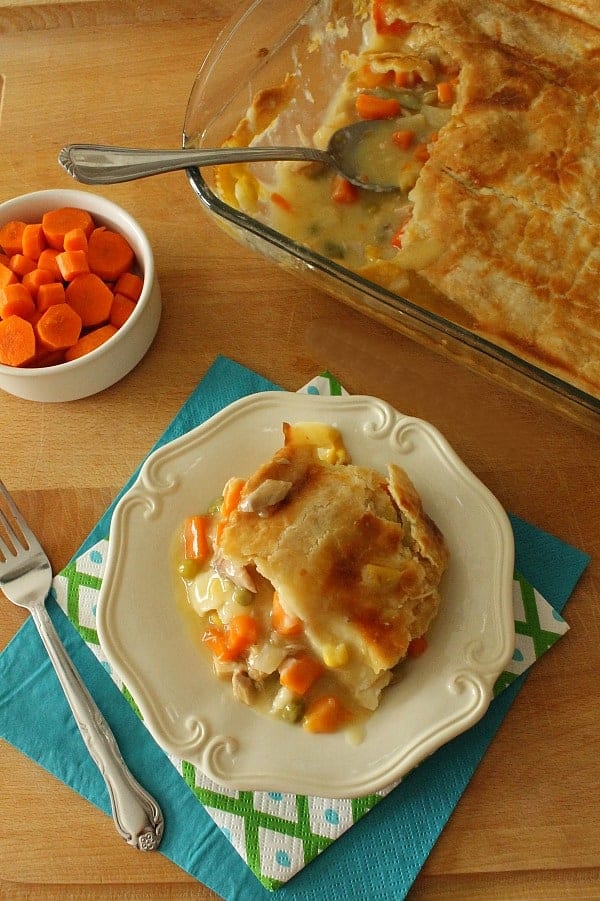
{"left": 171, "top": 423, "right": 448, "bottom": 732}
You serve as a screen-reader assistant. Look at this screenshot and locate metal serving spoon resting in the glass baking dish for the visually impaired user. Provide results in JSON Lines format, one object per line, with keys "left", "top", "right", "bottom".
{"left": 58, "top": 120, "right": 398, "bottom": 191}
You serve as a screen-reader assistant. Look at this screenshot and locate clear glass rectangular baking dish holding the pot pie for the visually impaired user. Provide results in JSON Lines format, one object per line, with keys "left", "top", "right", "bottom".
{"left": 183, "top": 0, "right": 600, "bottom": 429}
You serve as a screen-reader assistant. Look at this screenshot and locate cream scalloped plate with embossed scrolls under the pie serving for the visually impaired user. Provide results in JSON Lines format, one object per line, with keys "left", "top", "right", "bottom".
{"left": 98, "top": 392, "right": 514, "bottom": 797}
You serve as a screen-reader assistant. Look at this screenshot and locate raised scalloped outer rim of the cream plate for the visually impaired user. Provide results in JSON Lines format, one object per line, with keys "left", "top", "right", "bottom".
{"left": 97, "top": 391, "right": 514, "bottom": 798}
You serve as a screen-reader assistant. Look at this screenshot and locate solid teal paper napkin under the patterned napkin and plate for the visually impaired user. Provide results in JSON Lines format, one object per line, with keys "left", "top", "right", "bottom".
{"left": 0, "top": 358, "right": 588, "bottom": 901}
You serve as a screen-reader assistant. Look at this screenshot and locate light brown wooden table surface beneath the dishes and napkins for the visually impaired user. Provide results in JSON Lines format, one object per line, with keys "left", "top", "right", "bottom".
{"left": 0, "top": 0, "right": 600, "bottom": 901}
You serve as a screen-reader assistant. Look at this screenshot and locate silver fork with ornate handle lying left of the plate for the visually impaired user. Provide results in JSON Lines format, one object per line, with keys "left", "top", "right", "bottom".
{"left": 0, "top": 481, "right": 164, "bottom": 851}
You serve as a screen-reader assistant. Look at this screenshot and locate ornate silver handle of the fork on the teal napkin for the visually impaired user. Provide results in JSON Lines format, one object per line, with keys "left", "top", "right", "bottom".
{"left": 31, "top": 606, "right": 164, "bottom": 851}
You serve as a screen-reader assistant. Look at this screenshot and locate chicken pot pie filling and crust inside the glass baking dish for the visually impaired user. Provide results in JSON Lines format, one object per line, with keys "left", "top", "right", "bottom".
{"left": 217, "top": 0, "right": 600, "bottom": 397}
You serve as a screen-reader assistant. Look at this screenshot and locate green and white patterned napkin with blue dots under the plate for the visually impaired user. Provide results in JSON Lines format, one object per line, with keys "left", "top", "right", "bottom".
{"left": 53, "top": 373, "right": 569, "bottom": 890}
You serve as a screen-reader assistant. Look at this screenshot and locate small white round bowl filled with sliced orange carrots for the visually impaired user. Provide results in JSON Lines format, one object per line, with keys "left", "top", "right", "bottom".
{"left": 0, "top": 189, "right": 161, "bottom": 402}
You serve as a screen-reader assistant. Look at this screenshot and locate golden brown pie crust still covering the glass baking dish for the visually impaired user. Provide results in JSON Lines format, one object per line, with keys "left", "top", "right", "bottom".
{"left": 378, "top": 0, "right": 600, "bottom": 395}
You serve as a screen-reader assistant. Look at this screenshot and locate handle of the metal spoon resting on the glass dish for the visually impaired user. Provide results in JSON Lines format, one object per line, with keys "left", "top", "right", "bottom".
{"left": 58, "top": 144, "right": 331, "bottom": 185}
